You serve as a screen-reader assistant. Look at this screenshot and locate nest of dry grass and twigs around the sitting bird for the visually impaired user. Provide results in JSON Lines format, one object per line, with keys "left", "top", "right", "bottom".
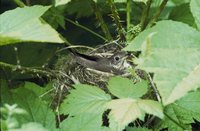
{"left": 49, "top": 44, "right": 145, "bottom": 107}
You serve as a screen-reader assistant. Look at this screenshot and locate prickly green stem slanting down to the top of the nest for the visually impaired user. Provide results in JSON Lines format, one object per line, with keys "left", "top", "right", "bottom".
{"left": 108, "top": 0, "right": 126, "bottom": 41}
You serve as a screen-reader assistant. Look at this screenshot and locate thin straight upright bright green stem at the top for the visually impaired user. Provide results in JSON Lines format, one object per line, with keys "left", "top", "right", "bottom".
{"left": 126, "top": 0, "right": 131, "bottom": 31}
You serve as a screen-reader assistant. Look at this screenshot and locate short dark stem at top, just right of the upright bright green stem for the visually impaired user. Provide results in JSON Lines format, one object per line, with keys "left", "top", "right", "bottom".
{"left": 140, "top": 0, "right": 152, "bottom": 30}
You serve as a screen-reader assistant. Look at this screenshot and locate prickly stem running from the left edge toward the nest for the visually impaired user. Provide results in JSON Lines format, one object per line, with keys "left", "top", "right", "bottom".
{"left": 0, "top": 62, "right": 56, "bottom": 78}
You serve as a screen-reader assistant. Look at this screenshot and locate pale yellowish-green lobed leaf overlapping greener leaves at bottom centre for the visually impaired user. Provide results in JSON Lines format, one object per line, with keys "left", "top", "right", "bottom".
{"left": 107, "top": 98, "right": 164, "bottom": 131}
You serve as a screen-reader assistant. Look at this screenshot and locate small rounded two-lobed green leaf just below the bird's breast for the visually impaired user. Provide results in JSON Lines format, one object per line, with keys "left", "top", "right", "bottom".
{"left": 108, "top": 77, "right": 147, "bottom": 99}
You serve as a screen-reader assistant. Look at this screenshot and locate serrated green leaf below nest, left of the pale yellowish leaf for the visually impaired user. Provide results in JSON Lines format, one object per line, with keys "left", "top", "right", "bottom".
{"left": 61, "top": 84, "right": 111, "bottom": 116}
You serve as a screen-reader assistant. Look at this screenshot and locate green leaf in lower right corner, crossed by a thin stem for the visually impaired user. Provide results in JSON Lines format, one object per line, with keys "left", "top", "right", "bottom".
{"left": 157, "top": 91, "right": 200, "bottom": 131}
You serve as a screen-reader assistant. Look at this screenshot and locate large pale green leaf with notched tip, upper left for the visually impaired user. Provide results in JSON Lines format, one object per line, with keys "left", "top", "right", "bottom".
{"left": 0, "top": 5, "right": 64, "bottom": 45}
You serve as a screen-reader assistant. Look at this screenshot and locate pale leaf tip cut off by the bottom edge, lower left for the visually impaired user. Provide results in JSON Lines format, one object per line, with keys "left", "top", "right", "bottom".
{"left": 9, "top": 122, "right": 49, "bottom": 131}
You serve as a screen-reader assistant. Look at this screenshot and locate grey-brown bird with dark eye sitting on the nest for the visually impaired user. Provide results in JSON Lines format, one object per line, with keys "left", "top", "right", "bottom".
{"left": 69, "top": 49, "right": 130, "bottom": 75}
